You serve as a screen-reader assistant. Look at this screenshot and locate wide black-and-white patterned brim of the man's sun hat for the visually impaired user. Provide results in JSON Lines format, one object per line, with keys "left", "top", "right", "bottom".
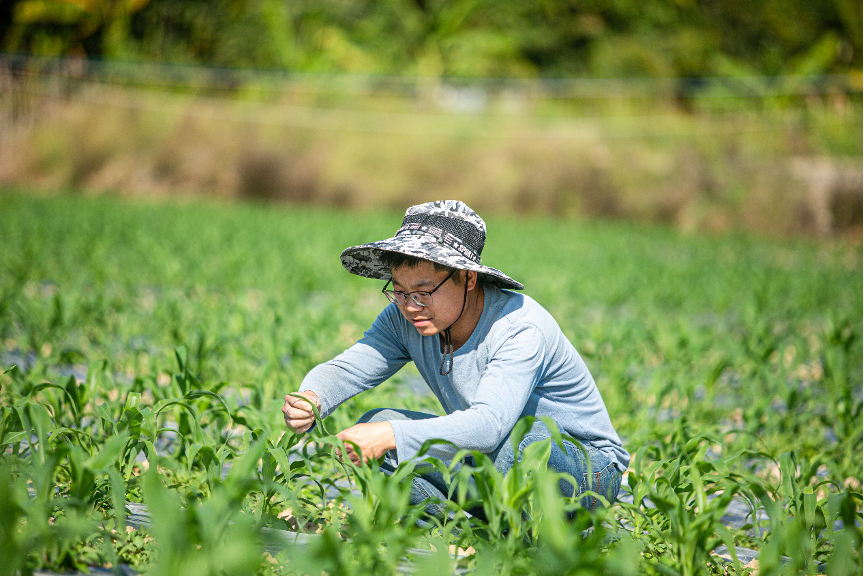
{"left": 340, "top": 235, "right": 525, "bottom": 290}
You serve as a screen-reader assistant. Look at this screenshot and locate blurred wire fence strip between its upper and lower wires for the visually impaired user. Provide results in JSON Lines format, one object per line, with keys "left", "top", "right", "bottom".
{"left": 0, "top": 54, "right": 862, "bottom": 140}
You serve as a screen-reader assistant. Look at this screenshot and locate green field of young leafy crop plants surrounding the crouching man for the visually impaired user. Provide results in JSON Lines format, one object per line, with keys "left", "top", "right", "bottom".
{"left": 0, "top": 191, "right": 864, "bottom": 574}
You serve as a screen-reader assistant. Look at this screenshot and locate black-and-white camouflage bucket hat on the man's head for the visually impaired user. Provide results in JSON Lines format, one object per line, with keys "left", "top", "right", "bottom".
{"left": 342, "top": 200, "right": 525, "bottom": 290}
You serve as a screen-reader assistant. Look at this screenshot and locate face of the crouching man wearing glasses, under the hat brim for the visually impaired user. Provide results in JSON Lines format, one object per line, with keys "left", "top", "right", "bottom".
{"left": 391, "top": 262, "right": 470, "bottom": 337}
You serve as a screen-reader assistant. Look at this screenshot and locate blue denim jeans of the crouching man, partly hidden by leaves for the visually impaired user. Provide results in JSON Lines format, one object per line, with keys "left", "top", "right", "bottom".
{"left": 357, "top": 409, "right": 621, "bottom": 519}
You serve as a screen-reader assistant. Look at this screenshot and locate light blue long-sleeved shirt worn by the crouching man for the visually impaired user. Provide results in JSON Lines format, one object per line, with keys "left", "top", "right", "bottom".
{"left": 300, "top": 285, "right": 630, "bottom": 472}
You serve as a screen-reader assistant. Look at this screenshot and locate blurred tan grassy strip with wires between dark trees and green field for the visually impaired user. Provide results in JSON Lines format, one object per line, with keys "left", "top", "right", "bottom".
{"left": 0, "top": 55, "right": 862, "bottom": 237}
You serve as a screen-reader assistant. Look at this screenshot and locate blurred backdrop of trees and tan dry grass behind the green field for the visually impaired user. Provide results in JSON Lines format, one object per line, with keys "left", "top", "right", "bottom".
{"left": 0, "top": 0, "right": 862, "bottom": 236}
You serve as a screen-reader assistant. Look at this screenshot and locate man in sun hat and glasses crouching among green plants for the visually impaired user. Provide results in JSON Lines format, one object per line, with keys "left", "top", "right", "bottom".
{"left": 282, "top": 200, "right": 630, "bottom": 507}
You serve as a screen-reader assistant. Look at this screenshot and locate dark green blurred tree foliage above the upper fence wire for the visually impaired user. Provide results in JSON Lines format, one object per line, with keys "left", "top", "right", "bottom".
{"left": 0, "top": 0, "right": 862, "bottom": 77}
